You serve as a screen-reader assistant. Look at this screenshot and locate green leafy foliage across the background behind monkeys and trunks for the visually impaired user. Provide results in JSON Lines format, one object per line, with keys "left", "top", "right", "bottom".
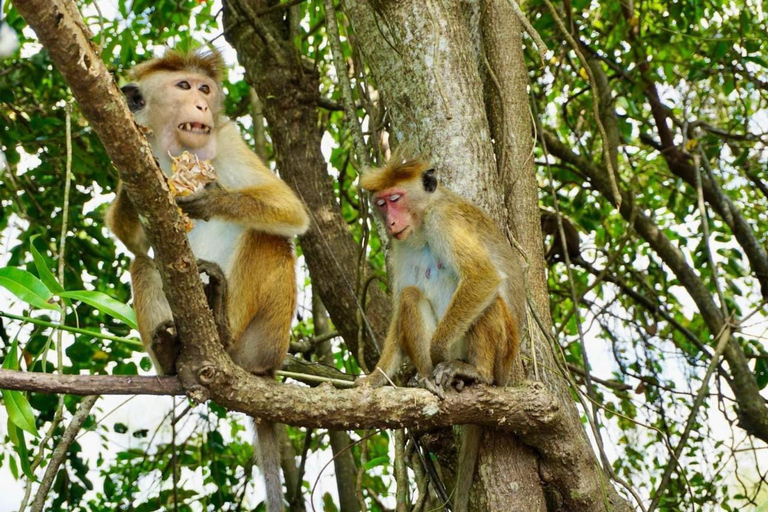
{"left": 0, "top": 0, "right": 768, "bottom": 511}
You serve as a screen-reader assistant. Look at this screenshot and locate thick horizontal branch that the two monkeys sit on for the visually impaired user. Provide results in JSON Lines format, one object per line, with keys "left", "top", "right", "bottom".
{"left": 0, "top": 362, "right": 604, "bottom": 492}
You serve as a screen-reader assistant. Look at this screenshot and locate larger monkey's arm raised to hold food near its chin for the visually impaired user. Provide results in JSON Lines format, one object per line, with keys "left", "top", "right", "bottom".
{"left": 176, "top": 177, "right": 309, "bottom": 238}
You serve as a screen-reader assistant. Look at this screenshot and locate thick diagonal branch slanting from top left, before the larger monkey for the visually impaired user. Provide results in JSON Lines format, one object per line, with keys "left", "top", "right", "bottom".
{"left": 15, "top": 0, "right": 218, "bottom": 396}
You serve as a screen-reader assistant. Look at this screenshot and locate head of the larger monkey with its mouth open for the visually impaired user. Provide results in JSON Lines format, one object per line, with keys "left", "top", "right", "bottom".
{"left": 122, "top": 51, "right": 223, "bottom": 159}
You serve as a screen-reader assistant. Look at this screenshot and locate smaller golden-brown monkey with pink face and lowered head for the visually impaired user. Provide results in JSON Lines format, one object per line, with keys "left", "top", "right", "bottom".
{"left": 359, "top": 157, "right": 525, "bottom": 511}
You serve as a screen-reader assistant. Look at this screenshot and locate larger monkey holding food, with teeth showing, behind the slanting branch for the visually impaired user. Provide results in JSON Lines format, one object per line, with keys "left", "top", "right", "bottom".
{"left": 106, "top": 50, "right": 309, "bottom": 512}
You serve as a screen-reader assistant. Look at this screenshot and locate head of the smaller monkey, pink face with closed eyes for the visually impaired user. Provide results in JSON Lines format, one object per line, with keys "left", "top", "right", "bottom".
{"left": 360, "top": 157, "right": 438, "bottom": 241}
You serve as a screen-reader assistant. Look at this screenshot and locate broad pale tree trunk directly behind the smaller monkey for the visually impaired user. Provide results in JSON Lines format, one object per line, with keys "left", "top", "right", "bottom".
{"left": 344, "top": 0, "right": 628, "bottom": 511}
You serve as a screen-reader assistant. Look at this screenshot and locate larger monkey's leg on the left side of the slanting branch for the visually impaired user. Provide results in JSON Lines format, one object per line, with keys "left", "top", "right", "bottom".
{"left": 130, "top": 254, "right": 180, "bottom": 375}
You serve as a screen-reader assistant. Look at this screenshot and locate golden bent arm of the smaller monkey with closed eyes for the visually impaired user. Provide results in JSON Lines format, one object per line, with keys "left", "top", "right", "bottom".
{"left": 430, "top": 218, "right": 502, "bottom": 364}
